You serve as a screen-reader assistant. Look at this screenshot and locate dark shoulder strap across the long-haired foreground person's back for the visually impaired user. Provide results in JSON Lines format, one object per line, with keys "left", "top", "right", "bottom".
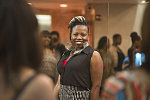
{"left": 12, "top": 73, "right": 38, "bottom": 100}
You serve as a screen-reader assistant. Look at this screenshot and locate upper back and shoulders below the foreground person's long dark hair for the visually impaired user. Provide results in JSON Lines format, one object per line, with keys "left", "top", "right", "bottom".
{"left": 0, "top": 68, "right": 54, "bottom": 100}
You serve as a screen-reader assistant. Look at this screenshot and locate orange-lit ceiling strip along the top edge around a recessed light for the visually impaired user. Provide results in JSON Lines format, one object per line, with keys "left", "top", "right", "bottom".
{"left": 28, "top": 0, "right": 141, "bottom": 10}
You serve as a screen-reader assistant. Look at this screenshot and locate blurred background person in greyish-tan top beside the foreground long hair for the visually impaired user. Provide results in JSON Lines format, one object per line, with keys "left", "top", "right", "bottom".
{"left": 39, "top": 30, "right": 58, "bottom": 83}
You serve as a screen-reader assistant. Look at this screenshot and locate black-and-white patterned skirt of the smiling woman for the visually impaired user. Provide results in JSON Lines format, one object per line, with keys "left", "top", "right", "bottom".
{"left": 59, "top": 85, "right": 90, "bottom": 100}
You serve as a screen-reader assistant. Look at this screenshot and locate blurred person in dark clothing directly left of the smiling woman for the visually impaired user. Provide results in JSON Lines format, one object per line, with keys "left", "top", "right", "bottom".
{"left": 50, "top": 31, "right": 66, "bottom": 60}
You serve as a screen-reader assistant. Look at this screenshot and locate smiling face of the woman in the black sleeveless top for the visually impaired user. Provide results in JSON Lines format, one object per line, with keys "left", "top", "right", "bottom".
{"left": 71, "top": 25, "right": 89, "bottom": 49}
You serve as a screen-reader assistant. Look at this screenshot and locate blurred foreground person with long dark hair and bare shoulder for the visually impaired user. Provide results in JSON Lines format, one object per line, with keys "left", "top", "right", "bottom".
{"left": 0, "top": 0, "right": 54, "bottom": 100}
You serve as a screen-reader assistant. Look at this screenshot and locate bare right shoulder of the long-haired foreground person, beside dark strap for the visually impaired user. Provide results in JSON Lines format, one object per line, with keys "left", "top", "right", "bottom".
{"left": 20, "top": 74, "right": 54, "bottom": 100}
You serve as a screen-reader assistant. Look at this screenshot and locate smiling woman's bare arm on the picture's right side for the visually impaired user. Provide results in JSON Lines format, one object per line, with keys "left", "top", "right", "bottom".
{"left": 90, "top": 51, "right": 103, "bottom": 100}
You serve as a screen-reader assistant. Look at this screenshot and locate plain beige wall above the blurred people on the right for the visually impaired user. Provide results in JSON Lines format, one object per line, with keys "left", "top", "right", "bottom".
{"left": 94, "top": 4, "right": 137, "bottom": 55}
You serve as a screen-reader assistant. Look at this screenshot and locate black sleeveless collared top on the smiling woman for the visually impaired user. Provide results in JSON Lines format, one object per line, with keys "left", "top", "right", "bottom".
{"left": 57, "top": 46, "right": 94, "bottom": 89}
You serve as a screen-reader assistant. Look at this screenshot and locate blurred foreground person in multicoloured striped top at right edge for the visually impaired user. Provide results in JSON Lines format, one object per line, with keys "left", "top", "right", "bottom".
{"left": 102, "top": 4, "right": 150, "bottom": 100}
